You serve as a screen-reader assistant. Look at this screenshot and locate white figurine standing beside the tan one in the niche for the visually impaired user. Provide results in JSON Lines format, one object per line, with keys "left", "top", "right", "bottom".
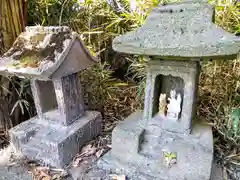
{"left": 167, "top": 90, "right": 182, "bottom": 120}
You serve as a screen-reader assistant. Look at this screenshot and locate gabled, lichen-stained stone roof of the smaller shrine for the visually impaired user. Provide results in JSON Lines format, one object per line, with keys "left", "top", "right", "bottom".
{"left": 0, "top": 26, "right": 96, "bottom": 78}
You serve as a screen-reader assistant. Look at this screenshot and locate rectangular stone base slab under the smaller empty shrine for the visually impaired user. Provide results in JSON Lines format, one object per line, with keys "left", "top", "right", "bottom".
{"left": 9, "top": 111, "right": 102, "bottom": 168}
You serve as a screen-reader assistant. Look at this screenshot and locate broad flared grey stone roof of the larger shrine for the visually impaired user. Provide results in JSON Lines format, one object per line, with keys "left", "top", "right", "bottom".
{"left": 113, "top": 0, "right": 240, "bottom": 58}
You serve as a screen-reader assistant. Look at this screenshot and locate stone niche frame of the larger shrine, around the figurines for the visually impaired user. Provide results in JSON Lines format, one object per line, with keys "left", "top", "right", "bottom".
{"left": 143, "top": 59, "right": 200, "bottom": 133}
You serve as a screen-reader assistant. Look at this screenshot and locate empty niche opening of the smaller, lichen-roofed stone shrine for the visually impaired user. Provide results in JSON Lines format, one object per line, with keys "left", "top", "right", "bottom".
{"left": 35, "top": 80, "right": 58, "bottom": 113}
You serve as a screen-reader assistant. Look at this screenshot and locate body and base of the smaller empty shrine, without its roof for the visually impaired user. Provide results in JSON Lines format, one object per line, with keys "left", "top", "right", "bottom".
{"left": 9, "top": 73, "right": 102, "bottom": 168}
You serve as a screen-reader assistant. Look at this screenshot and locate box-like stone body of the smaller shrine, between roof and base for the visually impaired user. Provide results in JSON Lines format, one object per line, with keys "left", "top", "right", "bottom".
{"left": 31, "top": 73, "right": 84, "bottom": 125}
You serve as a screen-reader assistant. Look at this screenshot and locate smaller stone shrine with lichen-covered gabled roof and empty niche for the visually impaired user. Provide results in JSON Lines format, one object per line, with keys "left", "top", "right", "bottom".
{"left": 0, "top": 26, "right": 102, "bottom": 167}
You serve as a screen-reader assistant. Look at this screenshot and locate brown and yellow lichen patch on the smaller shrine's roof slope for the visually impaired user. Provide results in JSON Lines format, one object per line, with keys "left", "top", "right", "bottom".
{"left": 4, "top": 31, "right": 72, "bottom": 68}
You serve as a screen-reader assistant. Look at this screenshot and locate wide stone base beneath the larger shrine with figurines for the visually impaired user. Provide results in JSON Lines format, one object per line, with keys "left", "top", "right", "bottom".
{"left": 84, "top": 112, "right": 213, "bottom": 180}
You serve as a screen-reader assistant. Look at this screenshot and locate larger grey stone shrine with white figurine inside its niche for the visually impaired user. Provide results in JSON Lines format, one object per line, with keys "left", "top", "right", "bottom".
{"left": 86, "top": 0, "right": 240, "bottom": 180}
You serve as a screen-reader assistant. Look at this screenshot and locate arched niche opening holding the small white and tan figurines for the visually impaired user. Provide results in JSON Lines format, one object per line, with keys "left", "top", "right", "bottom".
{"left": 152, "top": 74, "right": 185, "bottom": 120}
